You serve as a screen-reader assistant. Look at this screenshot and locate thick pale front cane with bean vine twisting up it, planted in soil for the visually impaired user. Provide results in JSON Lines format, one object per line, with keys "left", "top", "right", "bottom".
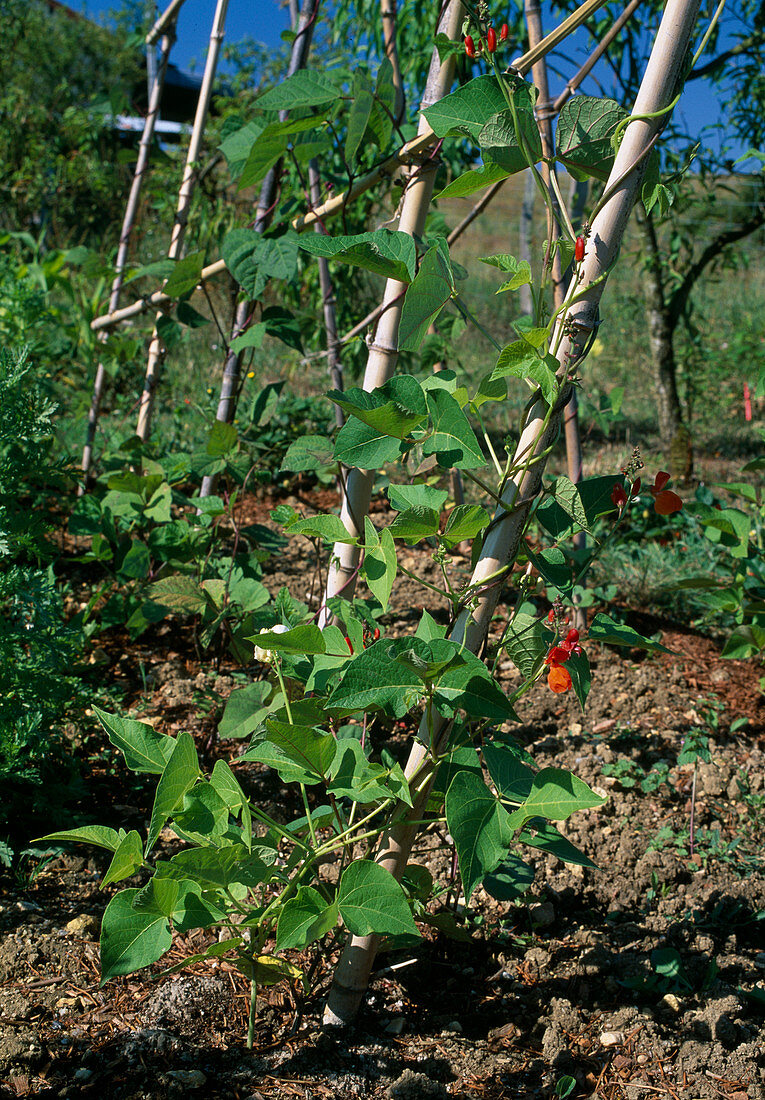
{"left": 325, "top": 0, "right": 700, "bottom": 1025}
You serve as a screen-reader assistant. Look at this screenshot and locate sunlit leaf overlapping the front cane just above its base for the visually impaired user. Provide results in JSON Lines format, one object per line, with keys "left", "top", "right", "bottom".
{"left": 337, "top": 859, "right": 419, "bottom": 936}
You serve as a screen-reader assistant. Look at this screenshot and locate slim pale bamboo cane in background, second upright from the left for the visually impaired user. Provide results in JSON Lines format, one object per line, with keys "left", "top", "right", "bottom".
{"left": 135, "top": 0, "right": 228, "bottom": 441}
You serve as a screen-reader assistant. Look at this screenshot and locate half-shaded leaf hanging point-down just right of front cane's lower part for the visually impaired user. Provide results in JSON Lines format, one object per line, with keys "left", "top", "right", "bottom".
{"left": 446, "top": 771, "right": 513, "bottom": 900}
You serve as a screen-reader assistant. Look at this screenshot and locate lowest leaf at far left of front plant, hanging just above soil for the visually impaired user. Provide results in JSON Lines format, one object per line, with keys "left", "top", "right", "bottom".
{"left": 101, "top": 890, "right": 173, "bottom": 985}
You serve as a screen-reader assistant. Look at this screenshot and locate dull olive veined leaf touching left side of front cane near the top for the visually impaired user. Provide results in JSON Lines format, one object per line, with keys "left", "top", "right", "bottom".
{"left": 556, "top": 96, "right": 629, "bottom": 180}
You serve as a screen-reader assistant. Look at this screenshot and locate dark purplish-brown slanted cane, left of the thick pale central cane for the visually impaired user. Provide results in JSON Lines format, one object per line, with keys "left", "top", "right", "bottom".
{"left": 199, "top": 0, "right": 319, "bottom": 497}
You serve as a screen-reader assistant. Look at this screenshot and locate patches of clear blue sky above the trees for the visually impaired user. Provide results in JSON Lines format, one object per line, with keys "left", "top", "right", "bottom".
{"left": 82, "top": 0, "right": 740, "bottom": 155}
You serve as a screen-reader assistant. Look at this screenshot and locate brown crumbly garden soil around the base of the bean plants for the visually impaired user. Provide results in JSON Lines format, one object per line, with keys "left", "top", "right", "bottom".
{"left": 0, "top": 504, "right": 765, "bottom": 1100}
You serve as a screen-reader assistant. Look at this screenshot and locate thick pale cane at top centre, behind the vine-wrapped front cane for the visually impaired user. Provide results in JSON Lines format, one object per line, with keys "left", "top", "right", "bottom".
{"left": 319, "top": 0, "right": 462, "bottom": 626}
